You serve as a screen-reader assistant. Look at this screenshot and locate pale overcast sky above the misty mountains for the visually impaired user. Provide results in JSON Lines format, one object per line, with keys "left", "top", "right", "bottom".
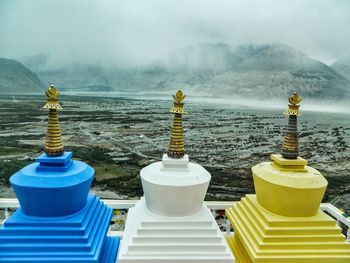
{"left": 0, "top": 0, "right": 350, "bottom": 67}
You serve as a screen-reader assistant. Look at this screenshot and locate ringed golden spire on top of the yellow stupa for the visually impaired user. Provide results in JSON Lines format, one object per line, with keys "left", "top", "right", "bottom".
{"left": 281, "top": 92, "right": 301, "bottom": 159}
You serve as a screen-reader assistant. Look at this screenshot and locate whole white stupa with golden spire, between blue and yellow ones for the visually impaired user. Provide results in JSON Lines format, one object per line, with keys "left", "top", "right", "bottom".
{"left": 118, "top": 90, "right": 234, "bottom": 263}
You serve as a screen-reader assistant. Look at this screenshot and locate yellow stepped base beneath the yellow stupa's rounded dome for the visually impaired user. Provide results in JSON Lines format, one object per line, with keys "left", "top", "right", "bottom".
{"left": 226, "top": 195, "right": 350, "bottom": 263}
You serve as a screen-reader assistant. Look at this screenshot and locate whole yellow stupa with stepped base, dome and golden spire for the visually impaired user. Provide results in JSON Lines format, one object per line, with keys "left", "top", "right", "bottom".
{"left": 226, "top": 93, "right": 350, "bottom": 263}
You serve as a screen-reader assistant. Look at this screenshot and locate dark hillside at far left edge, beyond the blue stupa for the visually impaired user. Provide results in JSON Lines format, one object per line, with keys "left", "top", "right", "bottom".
{"left": 0, "top": 58, "right": 44, "bottom": 94}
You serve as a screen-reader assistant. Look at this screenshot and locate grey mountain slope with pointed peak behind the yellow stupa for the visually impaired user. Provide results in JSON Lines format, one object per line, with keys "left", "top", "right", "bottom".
{"left": 203, "top": 44, "right": 350, "bottom": 99}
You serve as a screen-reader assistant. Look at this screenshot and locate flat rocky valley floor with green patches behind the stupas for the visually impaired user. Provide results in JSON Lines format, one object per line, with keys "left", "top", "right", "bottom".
{"left": 0, "top": 96, "right": 350, "bottom": 214}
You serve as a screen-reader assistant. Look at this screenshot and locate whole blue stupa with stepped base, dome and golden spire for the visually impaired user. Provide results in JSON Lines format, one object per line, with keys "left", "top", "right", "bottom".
{"left": 0, "top": 86, "right": 119, "bottom": 263}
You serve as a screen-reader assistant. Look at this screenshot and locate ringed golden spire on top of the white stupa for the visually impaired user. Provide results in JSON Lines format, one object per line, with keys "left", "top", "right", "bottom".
{"left": 168, "top": 90, "right": 186, "bottom": 159}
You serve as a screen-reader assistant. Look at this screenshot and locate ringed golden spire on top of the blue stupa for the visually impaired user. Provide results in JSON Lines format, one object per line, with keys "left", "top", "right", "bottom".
{"left": 43, "top": 85, "right": 64, "bottom": 156}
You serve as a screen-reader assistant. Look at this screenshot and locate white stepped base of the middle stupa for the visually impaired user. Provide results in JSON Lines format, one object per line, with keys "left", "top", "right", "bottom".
{"left": 118, "top": 198, "right": 234, "bottom": 263}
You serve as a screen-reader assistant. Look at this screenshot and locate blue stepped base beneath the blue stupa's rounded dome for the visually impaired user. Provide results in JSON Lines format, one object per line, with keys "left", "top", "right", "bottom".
{"left": 0, "top": 195, "right": 119, "bottom": 263}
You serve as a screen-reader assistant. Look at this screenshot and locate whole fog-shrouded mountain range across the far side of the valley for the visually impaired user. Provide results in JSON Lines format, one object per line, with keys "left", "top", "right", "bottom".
{"left": 29, "top": 43, "right": 350, "bottom": 100}
